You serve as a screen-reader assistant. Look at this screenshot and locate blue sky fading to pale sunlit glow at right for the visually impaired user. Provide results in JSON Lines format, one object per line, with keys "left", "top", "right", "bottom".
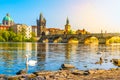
{"left": 0, "top": 0, "right": 120, "bottom": 33}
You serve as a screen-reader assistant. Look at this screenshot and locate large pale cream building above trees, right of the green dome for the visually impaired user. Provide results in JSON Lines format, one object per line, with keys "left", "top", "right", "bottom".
{"left": 11, "top": 24, "right": 32, "bottom": 39}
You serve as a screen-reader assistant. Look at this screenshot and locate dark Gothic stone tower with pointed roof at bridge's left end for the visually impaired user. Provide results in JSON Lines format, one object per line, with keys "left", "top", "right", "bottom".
{"left": 37, "top": 13, "right": 46, "bottom": 37}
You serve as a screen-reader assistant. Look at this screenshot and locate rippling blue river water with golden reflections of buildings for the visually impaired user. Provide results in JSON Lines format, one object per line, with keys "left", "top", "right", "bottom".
{"left": 0, "top": 43, "right": 120, "bottom": 76}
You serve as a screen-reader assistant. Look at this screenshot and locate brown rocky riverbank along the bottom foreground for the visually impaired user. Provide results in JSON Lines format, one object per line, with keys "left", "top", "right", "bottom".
{"left": 0, "top": 68, "right": 120, "bottom": 80}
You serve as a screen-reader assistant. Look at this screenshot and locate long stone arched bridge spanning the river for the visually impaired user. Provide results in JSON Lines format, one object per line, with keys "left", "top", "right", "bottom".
{"left": 39, "top": 33, "right": 120, "bottom": 44}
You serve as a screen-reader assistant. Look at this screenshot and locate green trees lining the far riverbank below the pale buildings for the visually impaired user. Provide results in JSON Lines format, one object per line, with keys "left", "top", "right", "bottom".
{"left": 0, "top": 30, "right": 36, "bottom": 42}
